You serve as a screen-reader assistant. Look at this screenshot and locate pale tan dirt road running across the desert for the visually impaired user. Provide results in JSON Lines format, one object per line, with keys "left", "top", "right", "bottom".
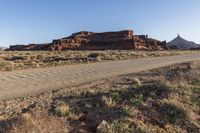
{"left": 0, "top": 54, "right": 200, "bottom": 100}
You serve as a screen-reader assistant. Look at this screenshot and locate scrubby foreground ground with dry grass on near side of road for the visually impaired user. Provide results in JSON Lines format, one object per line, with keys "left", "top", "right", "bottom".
{"left": 0, "top": 62, "right": 200, "bottom": 133}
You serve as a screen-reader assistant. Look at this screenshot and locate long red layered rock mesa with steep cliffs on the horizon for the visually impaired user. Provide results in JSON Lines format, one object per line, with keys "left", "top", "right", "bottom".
{"left": 9, "top": 30, "right": 168, "bottom": 51}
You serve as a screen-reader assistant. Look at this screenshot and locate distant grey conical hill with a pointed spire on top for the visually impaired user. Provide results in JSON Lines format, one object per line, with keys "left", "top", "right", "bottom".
{"left": 167, "top": 35, "right": 200, "bottom": 50}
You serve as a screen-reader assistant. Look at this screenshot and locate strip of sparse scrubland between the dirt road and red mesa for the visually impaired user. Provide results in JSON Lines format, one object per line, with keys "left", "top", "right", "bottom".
{"left": 0, "top": 50, "right": 199, "bottom": 71}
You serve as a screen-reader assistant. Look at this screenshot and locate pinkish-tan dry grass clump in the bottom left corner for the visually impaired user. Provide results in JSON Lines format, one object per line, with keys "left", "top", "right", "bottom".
{"left": 0, "top": 111, "right": 70, "bottom": 133}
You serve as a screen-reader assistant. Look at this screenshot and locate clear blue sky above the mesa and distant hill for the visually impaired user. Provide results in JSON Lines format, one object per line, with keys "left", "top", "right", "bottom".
{"left": 0, "top": 0, "right": 200, "bottom": 46}
